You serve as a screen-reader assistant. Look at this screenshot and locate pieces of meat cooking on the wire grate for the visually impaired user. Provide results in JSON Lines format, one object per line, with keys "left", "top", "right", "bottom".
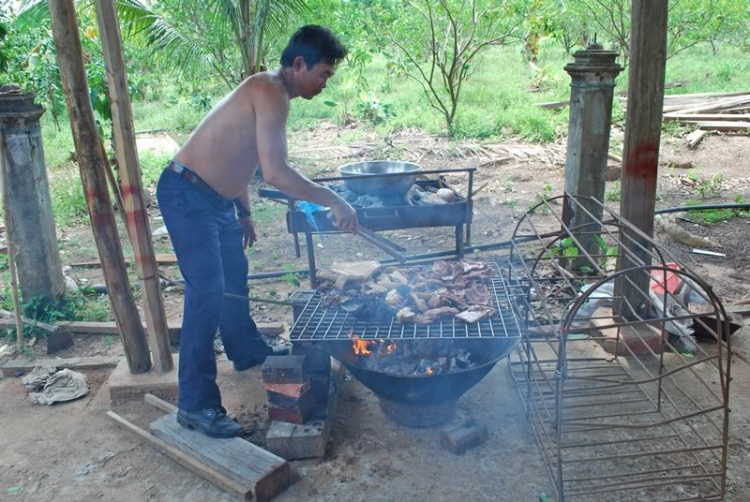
{"left": 320, "top": 261, "right": 497, "bottom": 324}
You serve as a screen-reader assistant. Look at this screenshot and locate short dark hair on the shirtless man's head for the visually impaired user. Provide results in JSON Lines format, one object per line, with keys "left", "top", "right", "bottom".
{"left": 281, "top": 24, "right": 346, "bottom": 70}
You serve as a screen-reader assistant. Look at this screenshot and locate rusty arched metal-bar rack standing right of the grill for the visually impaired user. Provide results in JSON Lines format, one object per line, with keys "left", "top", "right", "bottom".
{"left": 507, "top": 194, "right": 730, "bottom": 502}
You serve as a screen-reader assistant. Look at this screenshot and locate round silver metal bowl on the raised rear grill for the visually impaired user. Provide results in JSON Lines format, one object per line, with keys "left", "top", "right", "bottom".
{"left": 339, "top": 160, "right": 421, "bottom": 196}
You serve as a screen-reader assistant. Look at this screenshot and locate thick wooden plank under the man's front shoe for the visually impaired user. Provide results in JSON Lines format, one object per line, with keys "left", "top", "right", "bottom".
{"left": 150, "top": 413, "right": 292, "bottom": 502}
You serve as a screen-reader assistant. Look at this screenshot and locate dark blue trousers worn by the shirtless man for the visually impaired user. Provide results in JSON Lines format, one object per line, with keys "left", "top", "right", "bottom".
{"left": 156, "top": 169, "right": 268, "bottom": 411}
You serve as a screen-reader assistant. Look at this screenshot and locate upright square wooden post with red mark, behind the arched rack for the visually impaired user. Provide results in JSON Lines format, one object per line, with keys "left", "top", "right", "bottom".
{"left": 615, "top": 0, "right": 668, "bottom": 319}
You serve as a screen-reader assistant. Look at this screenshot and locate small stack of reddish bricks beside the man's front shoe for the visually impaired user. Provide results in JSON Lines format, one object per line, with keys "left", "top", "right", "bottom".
{"left": 263, "top": 356, "right": 315, "bottom": 425}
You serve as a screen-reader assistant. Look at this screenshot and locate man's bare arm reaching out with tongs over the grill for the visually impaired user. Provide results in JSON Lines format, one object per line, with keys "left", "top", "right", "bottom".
{"left": 255, "top": 81, "right": 359, "bottom": 232}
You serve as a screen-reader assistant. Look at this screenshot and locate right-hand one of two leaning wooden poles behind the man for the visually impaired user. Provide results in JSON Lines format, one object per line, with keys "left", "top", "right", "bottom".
{"left": 95, "top": 0, "right": 173, "bottom": 372}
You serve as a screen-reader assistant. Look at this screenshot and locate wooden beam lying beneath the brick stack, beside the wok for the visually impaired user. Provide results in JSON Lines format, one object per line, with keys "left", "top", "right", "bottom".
{"left": 266, "top": 361, "right": 346, "bottom": 460}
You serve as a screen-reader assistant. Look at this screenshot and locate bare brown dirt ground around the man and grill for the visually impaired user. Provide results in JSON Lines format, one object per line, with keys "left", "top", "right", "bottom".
{"left": 0, "top": 126, "right": 750, "bottom": 502}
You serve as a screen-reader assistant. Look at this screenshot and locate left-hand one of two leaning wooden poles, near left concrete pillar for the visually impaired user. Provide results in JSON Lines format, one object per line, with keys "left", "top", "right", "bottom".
{"left": 47, "top": 0, "right": 151, "bottom": 373}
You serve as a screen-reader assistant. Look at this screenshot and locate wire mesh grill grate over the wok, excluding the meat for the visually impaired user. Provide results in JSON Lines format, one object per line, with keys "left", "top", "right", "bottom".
{"left": 289, "top": 263, "right": 521, "bottom": 341}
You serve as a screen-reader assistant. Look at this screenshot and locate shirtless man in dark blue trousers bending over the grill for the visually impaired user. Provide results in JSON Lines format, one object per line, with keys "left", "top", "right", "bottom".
{"left": 156, "top": 26, "right": 358, "bottom": 437}
